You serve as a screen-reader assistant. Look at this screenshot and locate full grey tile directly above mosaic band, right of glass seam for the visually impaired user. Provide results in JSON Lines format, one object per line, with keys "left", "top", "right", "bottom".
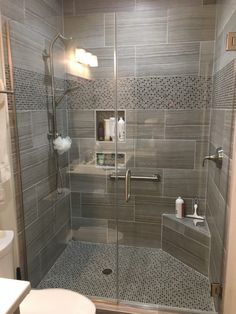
{"left": 136, "top": 43, "right": 200, "bottom": 76}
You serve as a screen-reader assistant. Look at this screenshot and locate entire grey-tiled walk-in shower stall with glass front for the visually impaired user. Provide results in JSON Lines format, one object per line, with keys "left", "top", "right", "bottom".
{"left": 2, "top": 0, "right": 236, "bottom": 313}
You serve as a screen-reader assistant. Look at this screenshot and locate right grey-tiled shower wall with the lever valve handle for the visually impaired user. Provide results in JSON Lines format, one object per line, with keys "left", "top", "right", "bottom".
{"left": 207, "top": 0, "right": 236, "bottom": 310}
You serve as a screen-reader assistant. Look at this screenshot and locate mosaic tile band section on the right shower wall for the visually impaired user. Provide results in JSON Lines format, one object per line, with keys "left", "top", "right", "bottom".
{"left": 212, "top": 60, "right": 236, "bottom": 109}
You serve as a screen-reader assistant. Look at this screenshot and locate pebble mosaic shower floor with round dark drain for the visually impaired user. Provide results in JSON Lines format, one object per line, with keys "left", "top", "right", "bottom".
{"left": 38, "top": 240, "right": 214, "bottom": 311}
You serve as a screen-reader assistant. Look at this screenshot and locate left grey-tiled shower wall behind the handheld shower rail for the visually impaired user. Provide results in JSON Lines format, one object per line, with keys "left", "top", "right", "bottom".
{"left": 0, "top": 0, "right": 70, "bottom": 286}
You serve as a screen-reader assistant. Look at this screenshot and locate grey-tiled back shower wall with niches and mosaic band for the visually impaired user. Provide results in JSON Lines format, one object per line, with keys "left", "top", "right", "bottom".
{"left": 64, "top": 0, "right": 215, "bottom": 253}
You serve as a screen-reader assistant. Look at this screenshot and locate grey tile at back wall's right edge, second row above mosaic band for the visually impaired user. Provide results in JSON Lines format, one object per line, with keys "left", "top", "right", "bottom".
{"left": 168, "top": 5, "right": 215, "bottom": 43}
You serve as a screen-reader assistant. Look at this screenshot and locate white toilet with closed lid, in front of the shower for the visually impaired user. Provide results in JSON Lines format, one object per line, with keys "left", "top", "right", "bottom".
{"left": 0, "top": 231, "right": 96, "bottom": 314}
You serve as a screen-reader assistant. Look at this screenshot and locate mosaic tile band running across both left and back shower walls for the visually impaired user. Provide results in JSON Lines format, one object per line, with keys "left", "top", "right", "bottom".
{"left": 10, "top": 68, "right": 212, "bottom": 110}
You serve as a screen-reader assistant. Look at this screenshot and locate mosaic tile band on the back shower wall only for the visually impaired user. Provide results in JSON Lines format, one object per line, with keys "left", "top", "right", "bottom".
{"left": 68, "top": 76, "right": 212, "bottom": 109}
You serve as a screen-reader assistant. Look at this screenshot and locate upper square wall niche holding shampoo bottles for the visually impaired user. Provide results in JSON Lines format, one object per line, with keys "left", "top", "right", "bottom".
{"left": 95, "top": 110, "right": 126, "bottom": 142}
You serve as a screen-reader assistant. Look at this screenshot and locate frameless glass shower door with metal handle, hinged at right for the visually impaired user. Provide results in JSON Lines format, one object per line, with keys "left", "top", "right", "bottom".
{"left": 116, "top": 1, "right": 219, "bottom": 311}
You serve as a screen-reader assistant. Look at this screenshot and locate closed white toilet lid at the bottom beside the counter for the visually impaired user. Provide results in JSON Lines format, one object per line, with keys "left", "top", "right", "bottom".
{"left": 20, "top": 289, "right": 96, "bottom": 314}
